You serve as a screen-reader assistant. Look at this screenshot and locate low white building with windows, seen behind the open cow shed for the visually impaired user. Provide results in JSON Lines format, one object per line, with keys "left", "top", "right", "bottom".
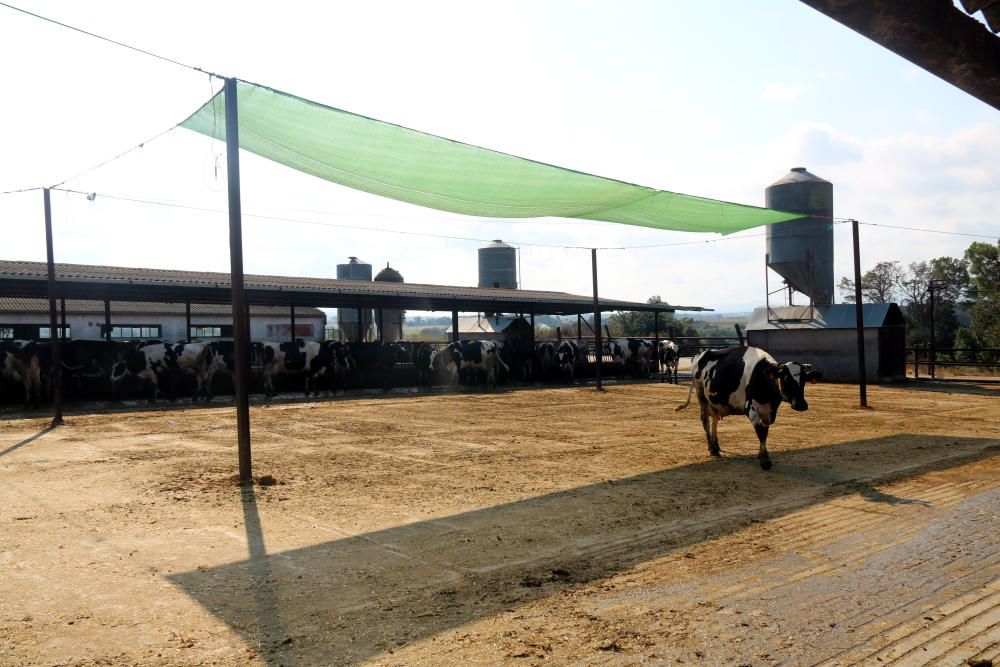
{"left": 0, "top": 298, "right": 326, "bottom": 340}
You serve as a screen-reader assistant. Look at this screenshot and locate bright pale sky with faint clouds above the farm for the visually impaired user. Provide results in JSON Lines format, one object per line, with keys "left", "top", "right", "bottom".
{"left": 0, "top": 0, "right": 1000, "bottom": 312}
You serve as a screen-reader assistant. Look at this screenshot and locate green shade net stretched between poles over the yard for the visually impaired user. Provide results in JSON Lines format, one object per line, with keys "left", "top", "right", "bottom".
{"left": 181, "top": 81, "right": 803, "bottom": 234}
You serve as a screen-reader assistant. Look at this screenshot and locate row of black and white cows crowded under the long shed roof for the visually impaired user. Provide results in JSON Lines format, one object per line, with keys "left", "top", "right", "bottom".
{"left": 0, "top": 338, "right": 679, "bottom": 407}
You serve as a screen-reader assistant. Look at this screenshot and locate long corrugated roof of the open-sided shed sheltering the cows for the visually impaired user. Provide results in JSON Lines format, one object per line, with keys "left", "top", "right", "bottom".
{"left": 0, "top": 260, "right": 711, "bottom": 315}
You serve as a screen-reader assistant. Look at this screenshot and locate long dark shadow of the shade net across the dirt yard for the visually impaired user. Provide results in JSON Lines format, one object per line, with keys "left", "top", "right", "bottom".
{"left": 170, "top": 434, "right": 1000, "bottom": 666}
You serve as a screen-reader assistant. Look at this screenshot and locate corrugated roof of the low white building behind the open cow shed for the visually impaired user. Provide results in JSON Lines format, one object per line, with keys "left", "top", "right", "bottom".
{"left": 0, "top": 297, "right": 326, "bottom": 318}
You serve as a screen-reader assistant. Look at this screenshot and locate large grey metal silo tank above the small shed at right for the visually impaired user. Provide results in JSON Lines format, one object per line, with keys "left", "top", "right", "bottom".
{"left": 764, "top": 167, "right": 833, "bottom": 305}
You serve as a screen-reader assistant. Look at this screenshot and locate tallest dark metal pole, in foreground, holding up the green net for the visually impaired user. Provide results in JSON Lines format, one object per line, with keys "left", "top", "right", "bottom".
{"left": 225, "top": 78, "right": 253, "bottom": 484}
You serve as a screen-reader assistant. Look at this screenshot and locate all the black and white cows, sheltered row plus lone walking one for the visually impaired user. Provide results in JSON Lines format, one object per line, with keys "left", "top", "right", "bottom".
{"left": 0, "top": 338, "right": 821, "bottom": 470}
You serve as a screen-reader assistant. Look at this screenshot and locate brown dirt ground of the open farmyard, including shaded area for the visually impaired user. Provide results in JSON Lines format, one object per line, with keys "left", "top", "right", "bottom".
{"left": 0, "top": 383, "right": 1000, "bottom": 666}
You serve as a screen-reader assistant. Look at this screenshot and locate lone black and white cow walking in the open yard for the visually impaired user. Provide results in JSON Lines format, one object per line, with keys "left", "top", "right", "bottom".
{"left": 677, "top": 347, "right": 822, "bottom": 470}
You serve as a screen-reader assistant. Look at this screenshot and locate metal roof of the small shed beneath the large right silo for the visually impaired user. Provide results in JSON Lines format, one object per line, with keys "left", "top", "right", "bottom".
{"left": 747, "top": 303, "right": 904, "bottom": 331}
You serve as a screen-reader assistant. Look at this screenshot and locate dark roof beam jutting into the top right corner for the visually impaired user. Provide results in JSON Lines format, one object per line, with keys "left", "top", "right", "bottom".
{"left": 801, "top": 0, "right": 1000, "bottom": 109}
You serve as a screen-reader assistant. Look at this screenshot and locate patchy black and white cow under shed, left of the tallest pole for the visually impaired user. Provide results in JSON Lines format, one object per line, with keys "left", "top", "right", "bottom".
{"left": 110, "top": 342, "right": 212, "bottom": 402}
